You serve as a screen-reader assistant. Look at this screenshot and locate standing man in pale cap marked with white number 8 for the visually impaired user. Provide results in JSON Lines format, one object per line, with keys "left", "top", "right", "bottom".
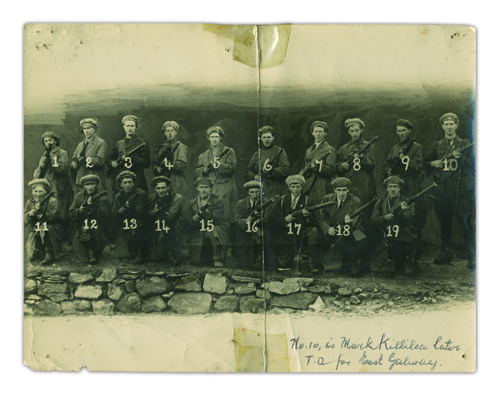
{"left": 337, "top": 118, "right": 375, "bottom": 205}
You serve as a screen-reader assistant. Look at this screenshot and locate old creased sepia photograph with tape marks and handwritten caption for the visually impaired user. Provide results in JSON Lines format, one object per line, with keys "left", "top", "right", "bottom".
{"left": 24, "top": 23, "right": 476, "bottom": 372}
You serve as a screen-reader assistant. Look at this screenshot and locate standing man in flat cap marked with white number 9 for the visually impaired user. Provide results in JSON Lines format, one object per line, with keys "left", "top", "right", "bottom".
{"left": 383, "top": 119, "right": 427, "bottom": 240}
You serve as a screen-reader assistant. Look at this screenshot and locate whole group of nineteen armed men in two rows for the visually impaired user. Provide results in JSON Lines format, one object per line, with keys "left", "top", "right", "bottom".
{"left": 24, "top": 113, "right": 475, "bottom": 276}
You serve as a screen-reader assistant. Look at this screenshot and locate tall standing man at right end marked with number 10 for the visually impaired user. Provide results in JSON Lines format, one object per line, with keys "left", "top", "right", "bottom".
{"left": 425, "top": 113, "right": 476, "bottom": 268}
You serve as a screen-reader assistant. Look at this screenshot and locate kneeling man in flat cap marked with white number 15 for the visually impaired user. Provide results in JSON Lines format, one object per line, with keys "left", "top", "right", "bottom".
{"left": 186, "top": 177, "right": 229, "bottom": 267}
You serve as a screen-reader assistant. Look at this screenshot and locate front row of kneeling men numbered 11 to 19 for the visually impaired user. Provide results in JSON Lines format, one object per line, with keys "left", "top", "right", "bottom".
{"left": 24, "top": 171, "right": 424, "bottom": 275}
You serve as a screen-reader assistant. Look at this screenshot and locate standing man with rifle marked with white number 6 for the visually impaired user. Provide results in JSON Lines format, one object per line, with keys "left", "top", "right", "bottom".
{"left": 247, "top": 126, "right": 290, "bottom": 199}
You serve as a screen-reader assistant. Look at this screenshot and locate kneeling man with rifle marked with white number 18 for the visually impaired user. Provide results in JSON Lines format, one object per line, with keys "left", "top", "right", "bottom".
{"left": 313, "top": 177, "right": 373, "bottom": 276}
